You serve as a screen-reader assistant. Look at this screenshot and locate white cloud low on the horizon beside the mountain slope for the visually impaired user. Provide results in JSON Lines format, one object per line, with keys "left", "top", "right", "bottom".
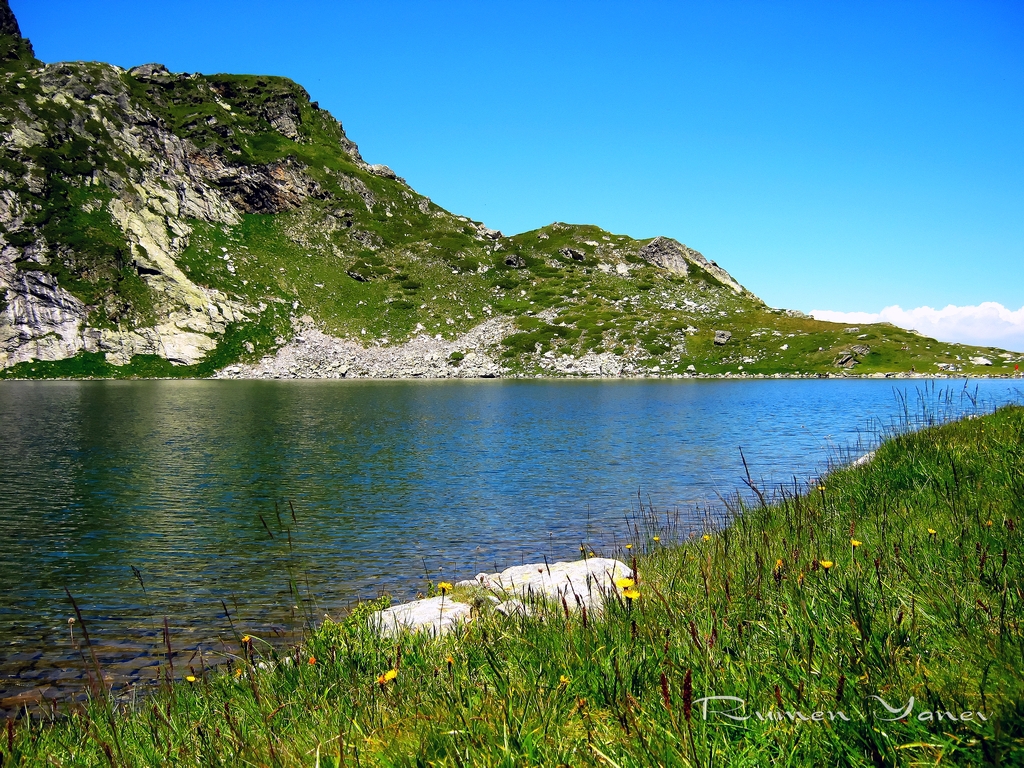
{"left": 811, "top": 301, "right": 1024, "bottom": 351}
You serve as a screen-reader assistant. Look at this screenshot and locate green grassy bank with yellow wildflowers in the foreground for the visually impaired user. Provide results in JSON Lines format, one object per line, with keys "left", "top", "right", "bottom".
{"left": 8, "top": 408, "right": 1024, "bottom": 766}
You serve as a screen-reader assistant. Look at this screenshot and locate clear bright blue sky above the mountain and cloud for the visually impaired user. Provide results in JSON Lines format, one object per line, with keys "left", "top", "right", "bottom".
{"left": 11, "top": 0, "right": 1024, "bottom": 325}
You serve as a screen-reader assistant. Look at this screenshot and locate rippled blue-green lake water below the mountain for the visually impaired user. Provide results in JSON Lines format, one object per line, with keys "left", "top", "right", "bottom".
{"left": 0, "top": 380, "right": 1015, "bottom": 710}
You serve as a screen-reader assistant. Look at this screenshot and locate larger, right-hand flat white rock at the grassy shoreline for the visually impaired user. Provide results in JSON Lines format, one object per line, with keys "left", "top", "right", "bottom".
{"left": 476, "top": 557, "right": 633, "bottom": 612}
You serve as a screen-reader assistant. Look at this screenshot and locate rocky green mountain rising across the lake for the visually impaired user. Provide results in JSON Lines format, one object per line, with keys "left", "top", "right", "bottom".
{"left": 0, "top": 0, "right": 1015, "bottom": 378}
